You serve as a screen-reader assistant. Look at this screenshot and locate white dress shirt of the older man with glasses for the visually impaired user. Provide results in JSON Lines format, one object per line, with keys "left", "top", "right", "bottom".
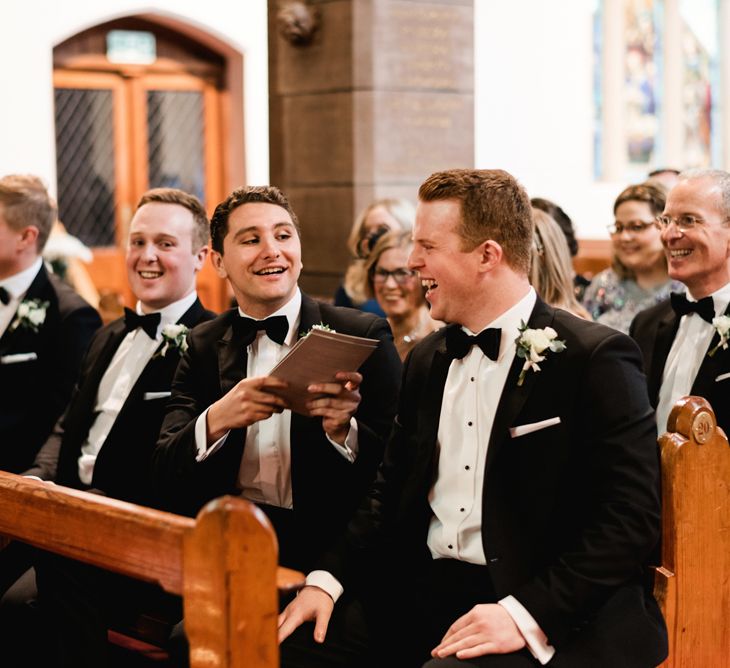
{"left": 656, "top": 283, "right": 730, "bottom": 434}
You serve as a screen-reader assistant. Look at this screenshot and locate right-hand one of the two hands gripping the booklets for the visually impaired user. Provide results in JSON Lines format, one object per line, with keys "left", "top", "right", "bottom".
{"left": 307, "top": 371, "right": 362, "bottom": 445}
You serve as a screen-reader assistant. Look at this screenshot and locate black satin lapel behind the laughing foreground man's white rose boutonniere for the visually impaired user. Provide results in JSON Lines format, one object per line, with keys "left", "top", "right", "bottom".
{"left": 484, "top": 297, "right": 560, "bottom": 477}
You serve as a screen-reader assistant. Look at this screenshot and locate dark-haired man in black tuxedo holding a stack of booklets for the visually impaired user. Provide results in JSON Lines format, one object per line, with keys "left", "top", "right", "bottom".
{"left": 153, "top": 186, "right": 401, "bottom": 570}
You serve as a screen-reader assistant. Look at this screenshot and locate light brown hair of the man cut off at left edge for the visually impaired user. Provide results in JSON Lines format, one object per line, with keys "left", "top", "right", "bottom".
{"left": 0, "top": 174, "right": 58, "bottom": 254}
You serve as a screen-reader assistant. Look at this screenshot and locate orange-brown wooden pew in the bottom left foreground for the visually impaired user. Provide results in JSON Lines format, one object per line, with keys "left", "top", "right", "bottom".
{"left": 0, "top": 472, "right": 303, "bottom": 668}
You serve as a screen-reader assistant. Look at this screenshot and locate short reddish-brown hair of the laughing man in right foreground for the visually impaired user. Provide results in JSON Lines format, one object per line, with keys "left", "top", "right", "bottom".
{"left": 418, "top": 169, "right": 533, "bottom": 275}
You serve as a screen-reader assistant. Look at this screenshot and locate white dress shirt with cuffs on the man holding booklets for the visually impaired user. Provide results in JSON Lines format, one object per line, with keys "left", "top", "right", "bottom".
{"left": 195, "top": 290, "right": 358, "bottom": 508}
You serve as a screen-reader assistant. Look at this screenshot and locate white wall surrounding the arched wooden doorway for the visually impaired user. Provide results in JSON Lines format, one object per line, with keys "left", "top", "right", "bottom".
{"left": 0, "top": 0, "right": 269, "bottom": 190}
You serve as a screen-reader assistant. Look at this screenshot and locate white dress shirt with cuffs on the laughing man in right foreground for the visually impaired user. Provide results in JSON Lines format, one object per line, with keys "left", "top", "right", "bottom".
{"left": 306, "top": 288, "right": 555, "bottom": 664}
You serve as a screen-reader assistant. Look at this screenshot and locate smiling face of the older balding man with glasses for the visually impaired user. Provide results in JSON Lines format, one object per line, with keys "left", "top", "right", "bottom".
{"left": 661, "top": 178, "right": 730, "bottom": 299}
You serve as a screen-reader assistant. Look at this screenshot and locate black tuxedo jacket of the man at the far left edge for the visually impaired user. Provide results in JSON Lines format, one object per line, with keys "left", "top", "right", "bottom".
{"left": 0, "top": 266, "right": 101, "bottom": 473}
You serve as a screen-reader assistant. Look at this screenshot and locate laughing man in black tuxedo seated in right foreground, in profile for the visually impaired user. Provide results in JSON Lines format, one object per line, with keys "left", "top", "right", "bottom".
{"left": 279, "top": 170, "right": 667, "bottom": 668}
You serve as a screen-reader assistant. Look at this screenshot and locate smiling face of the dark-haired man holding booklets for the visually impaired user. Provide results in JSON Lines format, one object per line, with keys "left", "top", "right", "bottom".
{"left": 212, "top": 202, "right": 302, "bottom": 318}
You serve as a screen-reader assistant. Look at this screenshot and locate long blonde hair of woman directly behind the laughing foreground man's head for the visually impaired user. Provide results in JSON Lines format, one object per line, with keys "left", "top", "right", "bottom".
{"left": 530, "top": 208, "right": 590, "bottom": 320}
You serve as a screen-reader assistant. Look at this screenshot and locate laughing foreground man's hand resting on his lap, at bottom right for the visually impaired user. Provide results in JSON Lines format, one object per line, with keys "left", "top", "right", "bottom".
{"left": 431, "top": 603, "right": 525, "bottom": 659}
